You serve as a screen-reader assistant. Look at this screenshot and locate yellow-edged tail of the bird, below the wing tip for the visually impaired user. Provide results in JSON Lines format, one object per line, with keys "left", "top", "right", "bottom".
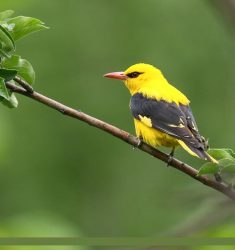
{"left": 178, "top": 140, "right": 218, "bottom": 164}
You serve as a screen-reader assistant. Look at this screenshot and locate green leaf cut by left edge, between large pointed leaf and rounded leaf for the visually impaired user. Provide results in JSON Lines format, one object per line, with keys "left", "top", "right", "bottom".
{"left": 0, "top": 25, "right": 15, "bottom": 57}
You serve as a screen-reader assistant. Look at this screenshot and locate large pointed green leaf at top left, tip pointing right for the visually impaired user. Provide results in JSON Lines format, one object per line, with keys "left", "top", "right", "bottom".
{"left": 7, "top": 16, "right": 48, "bottom": 41}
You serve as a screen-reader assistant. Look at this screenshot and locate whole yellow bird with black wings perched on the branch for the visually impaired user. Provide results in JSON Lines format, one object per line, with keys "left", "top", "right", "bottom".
{"left": 104, "top": 63, "right": 217, "bottom": 163}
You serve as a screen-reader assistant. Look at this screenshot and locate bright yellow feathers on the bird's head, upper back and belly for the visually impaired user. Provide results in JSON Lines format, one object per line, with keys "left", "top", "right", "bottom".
{"left": 124, "top": 63, "right": 189, "bottom": 151}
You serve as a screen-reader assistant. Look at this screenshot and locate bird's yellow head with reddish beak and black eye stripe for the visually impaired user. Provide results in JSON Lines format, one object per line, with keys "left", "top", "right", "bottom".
{"left": 104, "top": 63, "right": 163, "bottom": 94}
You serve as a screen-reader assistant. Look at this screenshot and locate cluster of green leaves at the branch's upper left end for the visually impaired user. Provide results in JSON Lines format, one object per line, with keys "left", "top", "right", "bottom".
{"left": 0, "top": 10, "right": 48, "bottom": 108}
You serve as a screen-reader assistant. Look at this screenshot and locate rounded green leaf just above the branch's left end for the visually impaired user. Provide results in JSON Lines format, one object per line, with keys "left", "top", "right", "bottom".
{"left": 2, "top": 55, "right": 35, "bottom": 84}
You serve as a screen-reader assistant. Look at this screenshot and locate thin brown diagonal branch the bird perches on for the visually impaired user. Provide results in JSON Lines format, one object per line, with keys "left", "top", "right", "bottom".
{"left": 6, "top": 78, "right": 235, "bottom": 201}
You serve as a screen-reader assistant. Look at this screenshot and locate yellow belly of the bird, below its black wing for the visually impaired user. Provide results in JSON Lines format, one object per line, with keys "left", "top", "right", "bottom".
{"left": 134, "top": 119, "right": 179, "bottom": 147}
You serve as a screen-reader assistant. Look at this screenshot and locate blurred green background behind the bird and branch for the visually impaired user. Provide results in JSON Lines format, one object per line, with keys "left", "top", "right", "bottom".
{"left": 0, "top": 0, "right": 235, "bottom": 250}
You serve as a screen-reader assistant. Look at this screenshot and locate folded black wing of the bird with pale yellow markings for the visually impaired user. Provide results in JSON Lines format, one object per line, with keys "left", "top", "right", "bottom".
{"left": 130, "top": 93, "right": 205, "bottom": 150}
